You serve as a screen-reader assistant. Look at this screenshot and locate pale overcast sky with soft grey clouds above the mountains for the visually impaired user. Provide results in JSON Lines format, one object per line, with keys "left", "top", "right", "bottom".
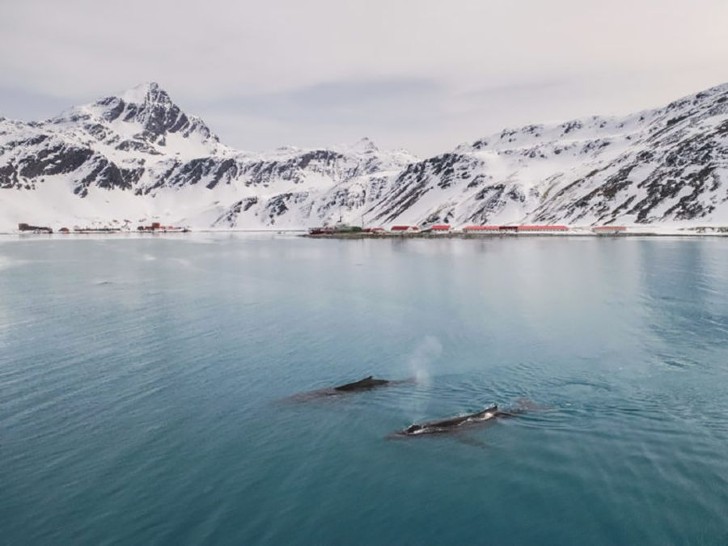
{"left": 0, "top": 0, "right": 728, "bottom": 156}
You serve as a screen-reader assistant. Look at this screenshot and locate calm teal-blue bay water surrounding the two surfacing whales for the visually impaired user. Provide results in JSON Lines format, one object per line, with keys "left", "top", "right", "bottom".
{"left": 0, "top": 234, "right": 728, "bottom": 546}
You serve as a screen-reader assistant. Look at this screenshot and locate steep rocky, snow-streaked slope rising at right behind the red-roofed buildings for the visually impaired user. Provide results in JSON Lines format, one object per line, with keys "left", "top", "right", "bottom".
{"left": 366, "top": 82, "right": 728, "bottom": 225}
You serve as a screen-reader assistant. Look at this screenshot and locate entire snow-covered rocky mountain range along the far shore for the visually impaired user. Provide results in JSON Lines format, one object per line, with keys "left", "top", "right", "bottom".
{"left": 0, "top": 83, "right": 728, "bottom": 231}
